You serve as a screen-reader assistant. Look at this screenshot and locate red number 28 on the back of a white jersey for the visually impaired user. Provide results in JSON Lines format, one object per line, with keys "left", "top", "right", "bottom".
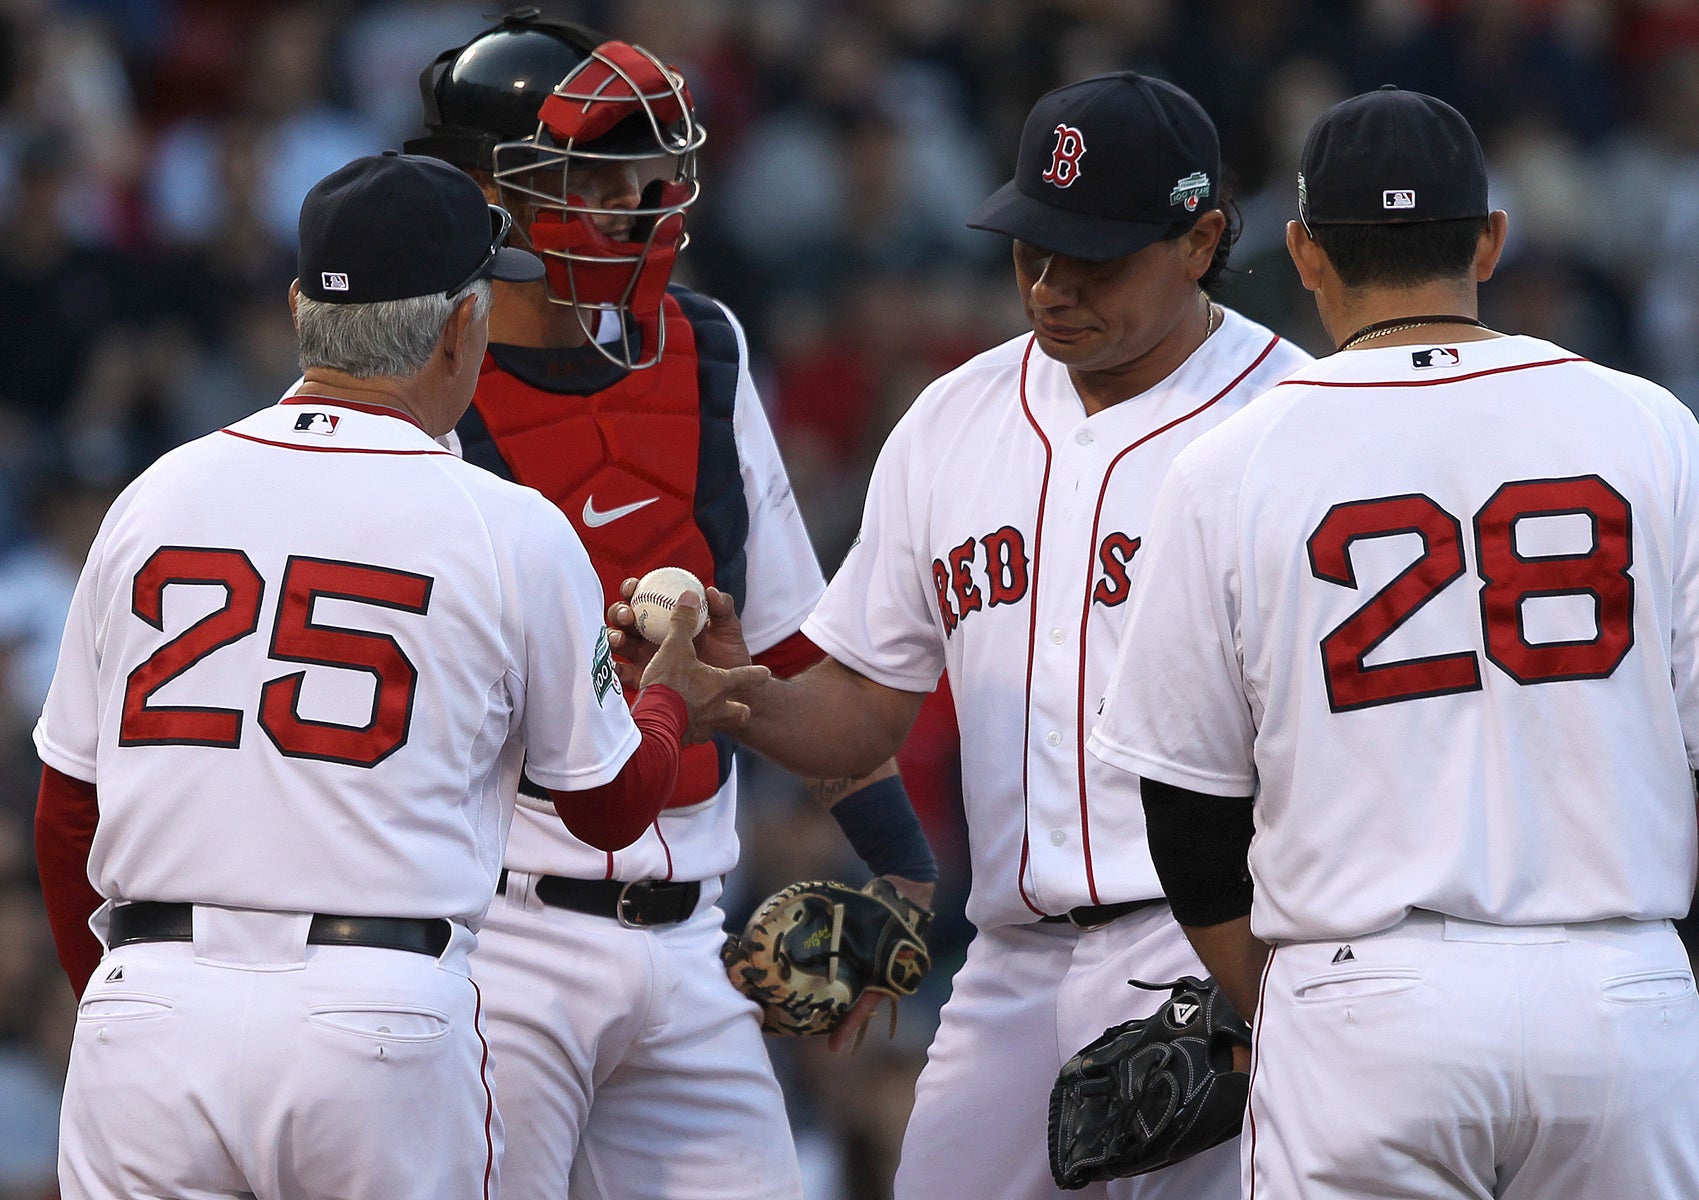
{"left": 1308, "top": 474, "right": 1634, "bottom": 712}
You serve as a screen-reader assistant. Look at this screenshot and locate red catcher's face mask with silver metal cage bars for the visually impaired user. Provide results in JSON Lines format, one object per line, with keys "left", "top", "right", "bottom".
{"left": 494, "top": 41, "right": 705, "bottom": 369}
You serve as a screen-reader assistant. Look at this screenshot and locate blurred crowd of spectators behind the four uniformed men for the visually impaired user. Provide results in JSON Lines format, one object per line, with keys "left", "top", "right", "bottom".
{"left": 0, "top": 0, "right": 1699, "bottom": 1200}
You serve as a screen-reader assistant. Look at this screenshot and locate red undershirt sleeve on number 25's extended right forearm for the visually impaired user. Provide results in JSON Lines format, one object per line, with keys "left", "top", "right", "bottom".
{"left": 549, "top": 683, "right": 690, "bottom": 850}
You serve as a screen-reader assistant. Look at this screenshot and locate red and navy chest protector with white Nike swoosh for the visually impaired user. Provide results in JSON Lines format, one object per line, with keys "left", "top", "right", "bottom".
{"left": 457, "top": 287, "right": 749, "bottom": 807}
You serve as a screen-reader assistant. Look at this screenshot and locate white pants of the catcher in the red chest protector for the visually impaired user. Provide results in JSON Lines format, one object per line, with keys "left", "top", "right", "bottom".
{"left": 472, "top": 872, "right": 802, "bottom": 1200}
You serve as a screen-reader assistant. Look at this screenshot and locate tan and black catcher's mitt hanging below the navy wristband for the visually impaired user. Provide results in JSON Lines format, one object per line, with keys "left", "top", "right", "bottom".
{"left": 720, "top": 879, "right": 933, "bottom": 1042}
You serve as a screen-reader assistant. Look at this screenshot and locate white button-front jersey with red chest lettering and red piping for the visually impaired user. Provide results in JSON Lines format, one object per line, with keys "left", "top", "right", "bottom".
{"left": 804, "top": 311, "right": 1310, "bottom": 928}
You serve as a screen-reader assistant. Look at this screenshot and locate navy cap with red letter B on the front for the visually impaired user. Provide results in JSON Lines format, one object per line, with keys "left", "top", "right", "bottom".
{"left": 968, "top": 71, "right": 1222, "bottom": 262}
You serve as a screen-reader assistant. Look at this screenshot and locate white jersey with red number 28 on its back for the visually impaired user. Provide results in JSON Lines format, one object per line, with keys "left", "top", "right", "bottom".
{"left": 1092, "top": 337, "right": 1699, "bottom": 942}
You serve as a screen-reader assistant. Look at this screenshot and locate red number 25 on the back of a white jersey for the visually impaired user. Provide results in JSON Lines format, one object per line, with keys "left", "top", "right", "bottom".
{"left": 119, "top": 546, "right": 432, "bottom": 767}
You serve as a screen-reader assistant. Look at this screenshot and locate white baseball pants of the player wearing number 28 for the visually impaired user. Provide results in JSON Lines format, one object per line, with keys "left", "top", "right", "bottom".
{"left": 1242, "top": 913, "right": 1699, "bottom": 1200}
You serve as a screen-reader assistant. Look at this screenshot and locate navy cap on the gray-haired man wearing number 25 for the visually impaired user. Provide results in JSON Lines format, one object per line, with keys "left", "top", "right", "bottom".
{"left": 296, "top": 150, "right": 544, "bottom": 304}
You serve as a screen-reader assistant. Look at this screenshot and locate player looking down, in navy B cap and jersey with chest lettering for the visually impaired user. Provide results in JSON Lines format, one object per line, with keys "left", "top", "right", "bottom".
{"left": 682, "top": 71, "right": 1308, "bottom": 1200}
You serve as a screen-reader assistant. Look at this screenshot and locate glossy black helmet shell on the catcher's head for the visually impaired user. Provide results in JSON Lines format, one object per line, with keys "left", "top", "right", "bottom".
{"left": 403, "top": 7, "right": 605, "bottom": 172}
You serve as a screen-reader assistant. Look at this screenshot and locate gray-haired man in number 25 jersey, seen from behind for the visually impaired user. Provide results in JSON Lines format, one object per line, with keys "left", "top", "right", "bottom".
{"left": 36, "top": 155, "right": 766, "bottom": 1200}
